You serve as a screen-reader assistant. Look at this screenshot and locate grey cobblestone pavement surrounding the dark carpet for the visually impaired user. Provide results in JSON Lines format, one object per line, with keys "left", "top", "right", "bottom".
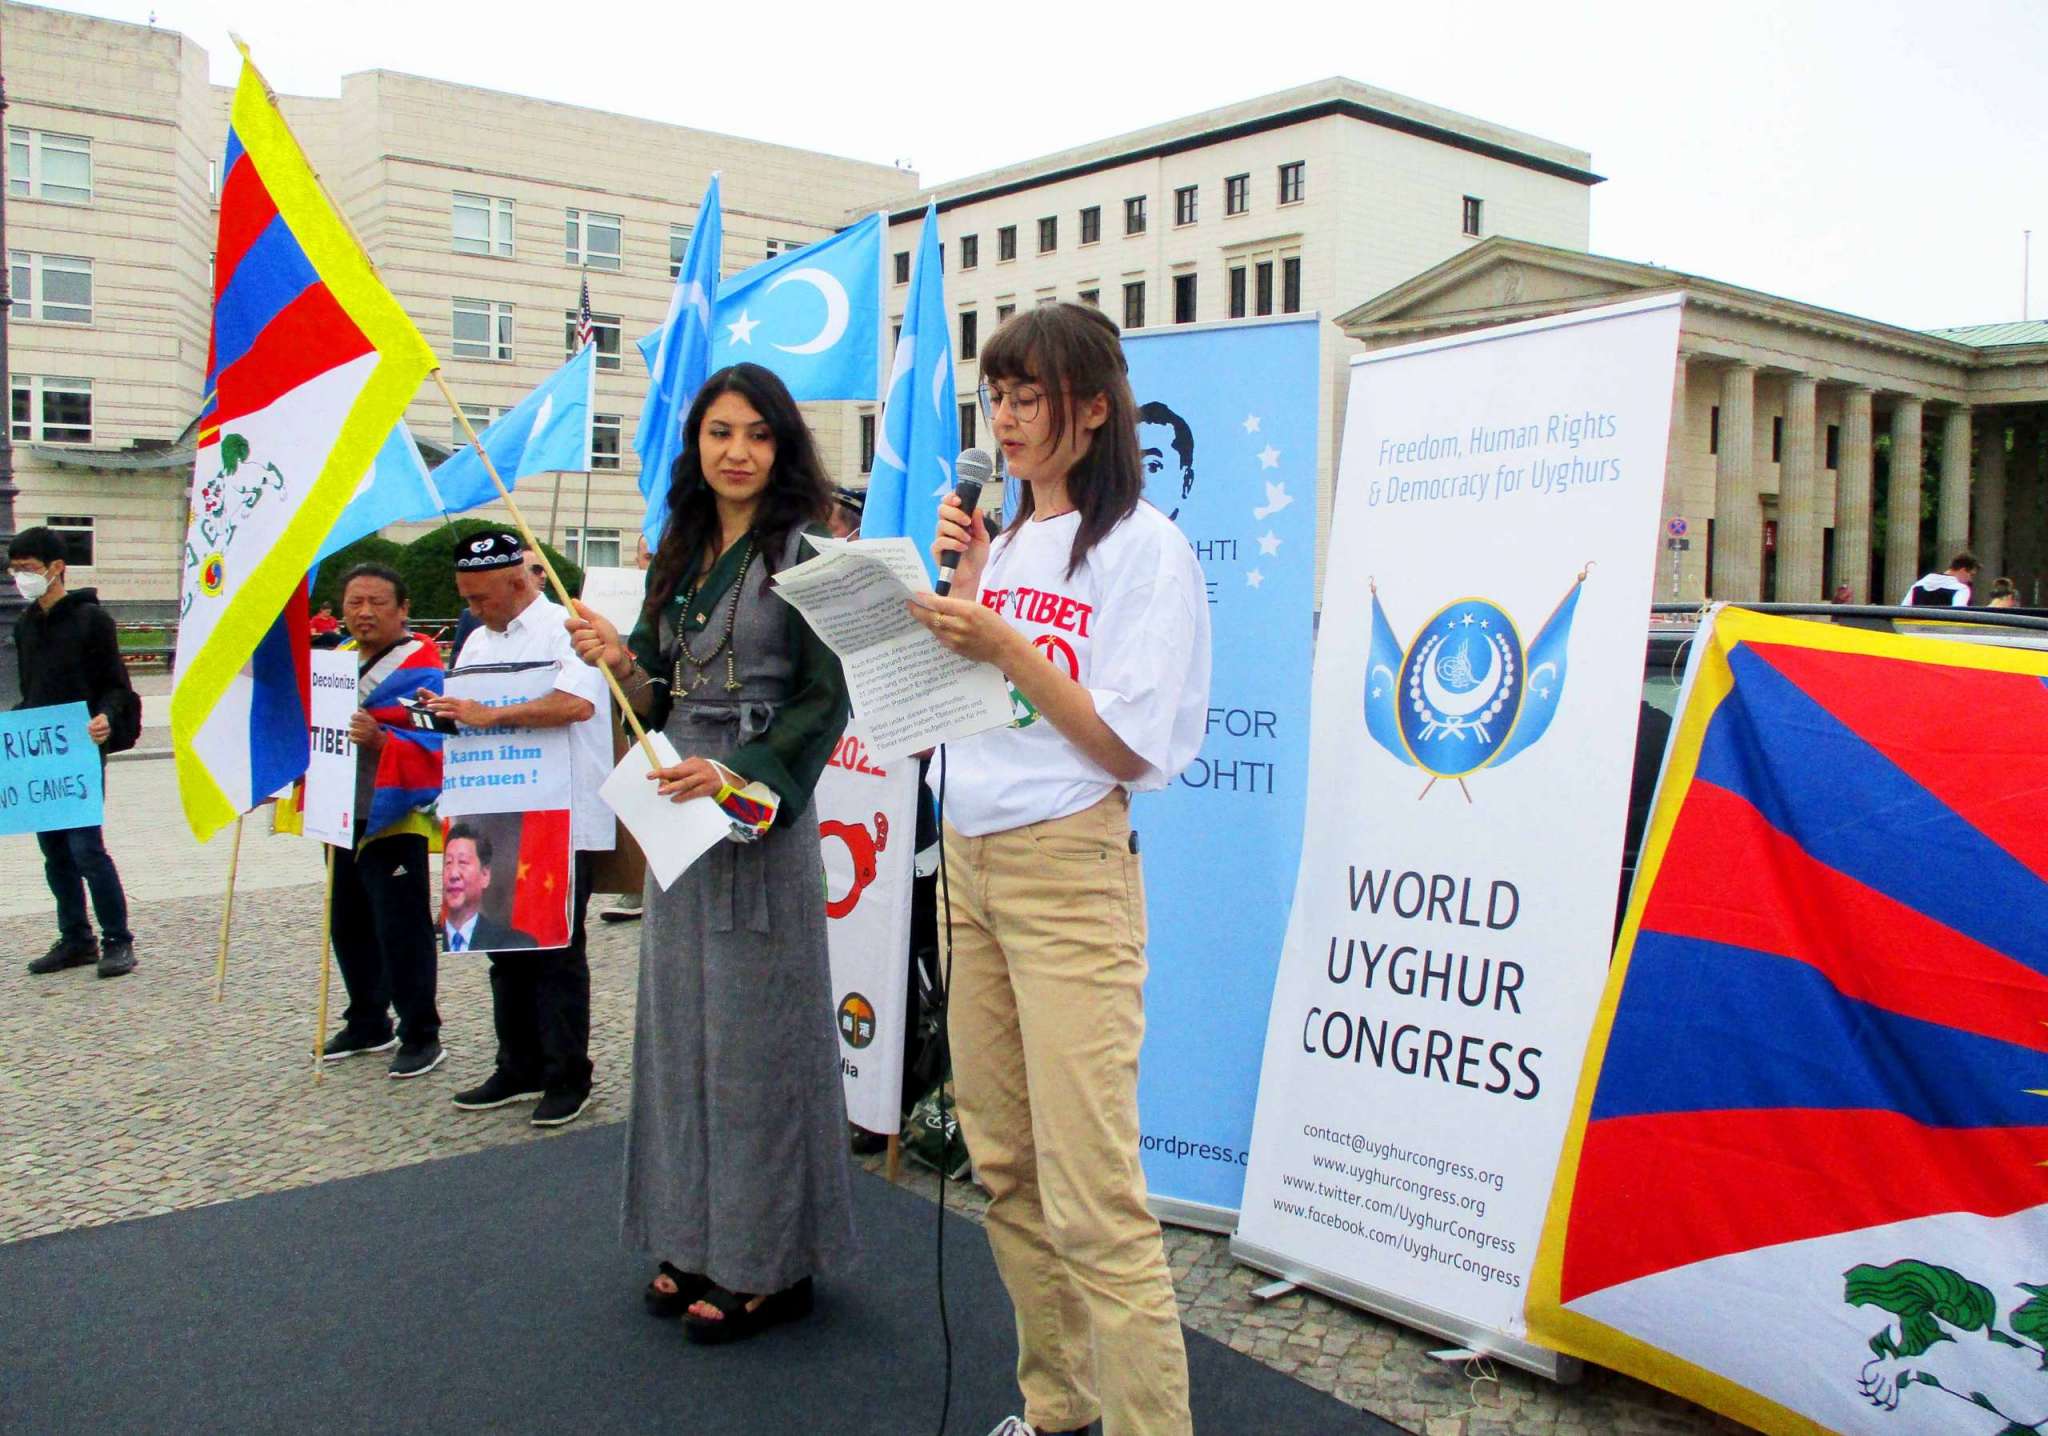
{"left": 0, "top": 757, "right": 1743, "bottom": 1436}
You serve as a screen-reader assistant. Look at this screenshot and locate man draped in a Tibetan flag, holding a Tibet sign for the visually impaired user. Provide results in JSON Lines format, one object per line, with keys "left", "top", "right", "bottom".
{"left": 322, "top": 563, "right": 442, "bottom": 1080}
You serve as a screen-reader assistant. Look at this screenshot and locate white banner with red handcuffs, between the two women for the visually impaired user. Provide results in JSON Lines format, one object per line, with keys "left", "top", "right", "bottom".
{"left": 817, "top": 729, "right": 918, "bottom": 1133}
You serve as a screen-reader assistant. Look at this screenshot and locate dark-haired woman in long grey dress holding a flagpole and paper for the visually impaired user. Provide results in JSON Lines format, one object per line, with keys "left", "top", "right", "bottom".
{"left": 569, "top": 365, "right": 854, "bottom": 1342}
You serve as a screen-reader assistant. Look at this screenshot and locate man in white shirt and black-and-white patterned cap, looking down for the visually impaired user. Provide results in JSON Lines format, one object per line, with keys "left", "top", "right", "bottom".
{"left": 428, "top": 529, "right": 616, "bottom": 1127}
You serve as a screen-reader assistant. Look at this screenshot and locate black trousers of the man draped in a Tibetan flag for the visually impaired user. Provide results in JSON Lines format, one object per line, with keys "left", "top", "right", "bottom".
{"left": 330, "top": 834, "right": 440, "bottom": 1047}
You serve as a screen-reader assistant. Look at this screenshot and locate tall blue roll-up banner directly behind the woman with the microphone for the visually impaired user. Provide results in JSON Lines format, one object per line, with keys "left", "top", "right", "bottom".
{"left": 1124, "top": 315, "right": 1321, "bottom": 1231}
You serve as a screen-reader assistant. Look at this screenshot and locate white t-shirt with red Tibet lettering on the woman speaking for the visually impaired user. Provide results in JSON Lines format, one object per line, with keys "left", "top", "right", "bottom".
{"left": 934, "top": 502, "right": 1208, "bottom": 838}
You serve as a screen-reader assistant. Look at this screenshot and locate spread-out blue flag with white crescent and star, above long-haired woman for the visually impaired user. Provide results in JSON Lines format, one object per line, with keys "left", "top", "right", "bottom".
{"left": 711, "top": 215, "right": 883, "bottom": 399}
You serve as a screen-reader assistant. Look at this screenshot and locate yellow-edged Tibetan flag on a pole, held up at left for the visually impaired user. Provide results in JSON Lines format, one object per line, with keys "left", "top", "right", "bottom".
{"left": 170, "top": 55, "right": 436, "bottom": 838}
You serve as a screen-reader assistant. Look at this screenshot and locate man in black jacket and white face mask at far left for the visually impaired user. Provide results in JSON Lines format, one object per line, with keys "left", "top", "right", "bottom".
{"left": 6, "top": 526, "right": 141, "bottom": 977}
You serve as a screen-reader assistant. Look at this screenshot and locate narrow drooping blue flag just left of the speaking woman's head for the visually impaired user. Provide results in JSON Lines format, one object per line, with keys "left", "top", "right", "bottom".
{"left": 860, "top": 207, "right": 961, "bottom": 576}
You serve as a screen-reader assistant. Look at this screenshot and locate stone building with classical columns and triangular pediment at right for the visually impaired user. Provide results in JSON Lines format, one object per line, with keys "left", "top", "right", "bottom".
{"left": 1337, "top": 238, "right": 2048, "bottom": 606}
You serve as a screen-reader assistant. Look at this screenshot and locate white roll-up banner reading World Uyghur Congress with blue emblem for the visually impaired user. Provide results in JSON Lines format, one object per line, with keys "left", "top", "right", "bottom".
{"left": 1231, "top": 297, "right": 1679, "bottom": 1377}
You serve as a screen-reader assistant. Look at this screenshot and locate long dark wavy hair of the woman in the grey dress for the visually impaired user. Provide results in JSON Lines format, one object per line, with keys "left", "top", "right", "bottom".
{"left": 643, "top": 365, "right": 831, "bottom": 625}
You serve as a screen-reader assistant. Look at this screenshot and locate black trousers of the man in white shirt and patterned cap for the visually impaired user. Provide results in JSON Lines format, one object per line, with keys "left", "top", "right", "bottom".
{"left": 492, "top": 852, "right": 596, "bottom": 1096}
